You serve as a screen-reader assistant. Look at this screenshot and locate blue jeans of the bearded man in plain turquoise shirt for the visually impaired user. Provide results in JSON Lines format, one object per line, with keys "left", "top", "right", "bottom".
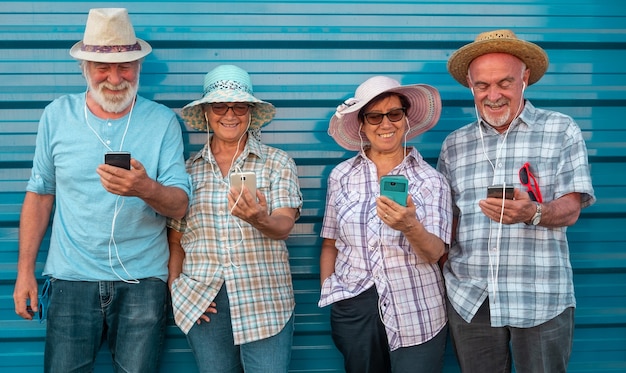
{"left": 44, "top": 278, "right": 168, "bottom": 373}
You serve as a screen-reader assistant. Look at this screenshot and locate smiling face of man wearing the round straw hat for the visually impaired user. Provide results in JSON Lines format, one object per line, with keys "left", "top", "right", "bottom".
{"left": 467, "top": 53, "right": 530, "bottom": 132}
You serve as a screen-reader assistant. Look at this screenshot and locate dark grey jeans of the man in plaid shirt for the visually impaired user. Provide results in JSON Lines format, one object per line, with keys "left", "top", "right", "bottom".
{"left": 448, "top": 299, "right": 574, "bottom": 373}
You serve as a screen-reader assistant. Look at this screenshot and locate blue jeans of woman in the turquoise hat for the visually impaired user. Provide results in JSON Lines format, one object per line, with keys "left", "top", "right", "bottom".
{"left": 187, "top": 285, "right": 293, "bottom": 373}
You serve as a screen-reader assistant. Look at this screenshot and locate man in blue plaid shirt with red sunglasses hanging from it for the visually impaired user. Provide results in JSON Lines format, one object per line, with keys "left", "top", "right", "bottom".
{"left": 437, "top": 30, "right": 595, "bottom": 373}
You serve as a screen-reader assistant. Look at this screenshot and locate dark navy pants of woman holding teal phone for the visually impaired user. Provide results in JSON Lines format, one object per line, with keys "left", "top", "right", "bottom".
{"left": 330, "top": 287, "right": 448, "bottom": 373}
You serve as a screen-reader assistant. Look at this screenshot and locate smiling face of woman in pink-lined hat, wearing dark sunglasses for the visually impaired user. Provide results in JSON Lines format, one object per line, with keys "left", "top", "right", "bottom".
{"left": 361, "top": 94, "right": 406, "bottom": 153}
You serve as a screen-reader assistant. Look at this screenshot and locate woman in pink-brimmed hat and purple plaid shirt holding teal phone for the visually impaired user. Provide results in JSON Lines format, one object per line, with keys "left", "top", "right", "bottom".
{"left": 319, "top": 76, "right": 452, "bottom": 373}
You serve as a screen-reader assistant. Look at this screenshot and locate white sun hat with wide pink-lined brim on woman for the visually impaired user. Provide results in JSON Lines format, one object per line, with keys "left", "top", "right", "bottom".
{"left": 328, "top": 76, "right": 441, "bottom": 150}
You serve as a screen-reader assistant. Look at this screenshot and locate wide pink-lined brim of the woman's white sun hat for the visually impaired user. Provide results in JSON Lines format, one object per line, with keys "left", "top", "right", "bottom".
{"left": 328, "top": 84, "right": 441, "bottom": 151}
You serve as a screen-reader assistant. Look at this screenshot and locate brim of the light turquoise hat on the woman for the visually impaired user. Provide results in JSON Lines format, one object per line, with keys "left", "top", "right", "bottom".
{"left": 180, "top": 90, "right": 276, "bottom": 131}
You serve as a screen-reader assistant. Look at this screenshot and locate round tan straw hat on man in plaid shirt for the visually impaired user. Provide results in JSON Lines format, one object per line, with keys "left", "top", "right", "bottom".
{"left": 448, "top": 30, "right": 549, "bottom": 87}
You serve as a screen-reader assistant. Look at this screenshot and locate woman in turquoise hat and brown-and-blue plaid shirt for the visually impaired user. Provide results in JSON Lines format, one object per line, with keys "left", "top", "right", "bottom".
{"left": 169, "top": 65, "right": 302, "bottom": 373}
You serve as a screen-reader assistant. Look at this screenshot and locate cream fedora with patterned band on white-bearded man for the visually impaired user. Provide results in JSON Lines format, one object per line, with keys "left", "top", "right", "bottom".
{"left": 70, "top": 8, "right": 152, "bottom": 63}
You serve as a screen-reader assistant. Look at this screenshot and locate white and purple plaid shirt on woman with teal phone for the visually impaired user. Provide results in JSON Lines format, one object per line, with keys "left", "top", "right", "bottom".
{"left": 319, "top": 148, "right": 452, "bottom": 350}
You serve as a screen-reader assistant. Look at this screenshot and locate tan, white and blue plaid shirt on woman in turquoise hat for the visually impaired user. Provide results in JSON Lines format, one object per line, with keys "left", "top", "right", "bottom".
{"left": 169, "top": 136, "right": 302, "bottom": 345}
